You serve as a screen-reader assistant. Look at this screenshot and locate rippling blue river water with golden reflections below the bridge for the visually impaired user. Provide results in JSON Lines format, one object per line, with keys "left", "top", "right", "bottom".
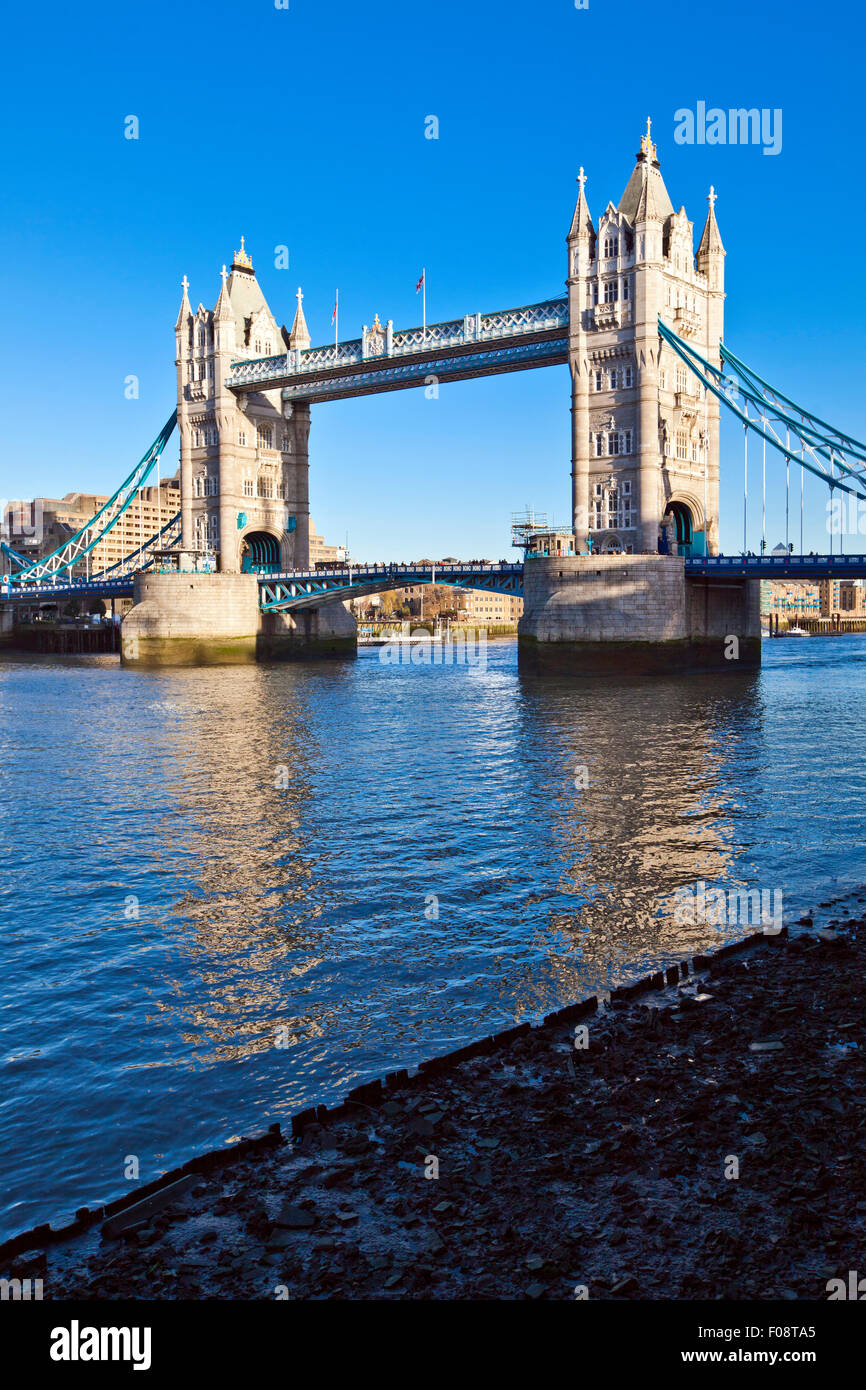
{"left": 0, "top": 637, "right": 866, "bottom": 1238}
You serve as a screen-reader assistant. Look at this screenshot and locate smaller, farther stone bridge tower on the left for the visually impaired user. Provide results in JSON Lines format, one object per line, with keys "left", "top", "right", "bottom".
{"left": 175, "top": 246, "right": 310, "bottom": 574}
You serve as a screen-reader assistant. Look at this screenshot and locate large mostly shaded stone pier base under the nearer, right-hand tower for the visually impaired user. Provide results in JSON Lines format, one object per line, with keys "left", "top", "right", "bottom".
{"left": 517, "top": 555, "right": 760, "bottom": 676}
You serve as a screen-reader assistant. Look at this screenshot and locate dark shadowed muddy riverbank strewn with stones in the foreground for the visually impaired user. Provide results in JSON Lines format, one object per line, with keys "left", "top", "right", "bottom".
{"left": 22, "top": 894, "right": 866, "bottom": 1300}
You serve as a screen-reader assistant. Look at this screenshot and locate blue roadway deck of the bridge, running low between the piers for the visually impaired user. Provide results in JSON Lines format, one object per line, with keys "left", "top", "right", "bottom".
{"left": 0, "top": 555, "right": 866, "bottom": 610}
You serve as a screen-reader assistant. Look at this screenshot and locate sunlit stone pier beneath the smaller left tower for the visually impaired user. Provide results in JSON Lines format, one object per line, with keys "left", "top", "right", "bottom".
{"left": 121, "top": 571, "right": 357, "bottom": 666}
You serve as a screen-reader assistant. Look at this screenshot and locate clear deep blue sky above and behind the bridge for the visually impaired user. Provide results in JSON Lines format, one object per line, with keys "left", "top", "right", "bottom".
{"left": 0, "top": 0, "right": 866, "bottom": 559}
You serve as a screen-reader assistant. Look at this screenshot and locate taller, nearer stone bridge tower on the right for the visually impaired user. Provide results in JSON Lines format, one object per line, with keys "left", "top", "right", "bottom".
{"left": 567, "top": 121, "right": 724, "bottom": 555}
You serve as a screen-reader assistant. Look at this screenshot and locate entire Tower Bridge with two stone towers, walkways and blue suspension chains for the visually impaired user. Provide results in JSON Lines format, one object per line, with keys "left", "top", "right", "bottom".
{"left": 3, "top": 122, "right": 866, "bottom": 670}
